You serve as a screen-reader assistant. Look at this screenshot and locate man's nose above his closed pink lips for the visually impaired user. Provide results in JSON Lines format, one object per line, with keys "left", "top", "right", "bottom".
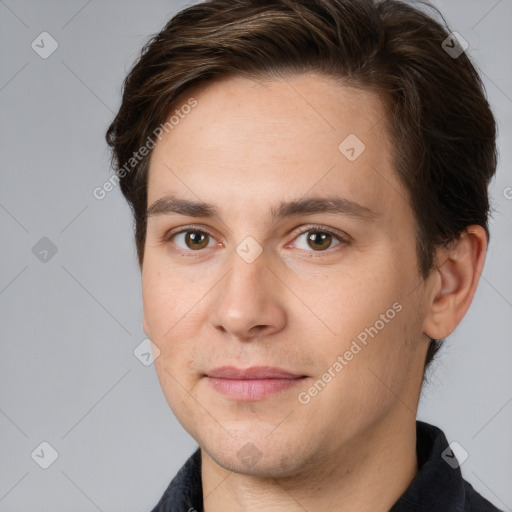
{"left": 211, "top": 252, "right": 287, "bottom": 341}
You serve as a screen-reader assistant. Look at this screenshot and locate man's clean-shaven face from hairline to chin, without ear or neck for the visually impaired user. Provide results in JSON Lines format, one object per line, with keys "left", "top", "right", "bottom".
{"left": 142, "top": 74, "right": 427, "bottom": 477}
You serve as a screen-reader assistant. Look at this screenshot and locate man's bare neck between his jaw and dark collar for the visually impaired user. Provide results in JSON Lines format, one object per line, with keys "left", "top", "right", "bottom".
{"left": 201, "top": 407, "right": 418, "bottom": 512}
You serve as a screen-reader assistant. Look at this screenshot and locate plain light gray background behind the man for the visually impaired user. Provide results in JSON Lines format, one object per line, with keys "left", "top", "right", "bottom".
{"left": 0, "top": 0, "right": 512, "bottom": 512}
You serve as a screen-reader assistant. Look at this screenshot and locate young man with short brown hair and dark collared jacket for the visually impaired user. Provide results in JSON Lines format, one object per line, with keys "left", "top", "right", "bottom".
{"left": 107, "top": 0, "right": 498, "bottom": 512}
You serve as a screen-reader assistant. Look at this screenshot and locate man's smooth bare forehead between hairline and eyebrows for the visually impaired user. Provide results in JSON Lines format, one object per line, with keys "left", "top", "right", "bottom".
{"left": 148, "top": 74, "right": 405, "bottom": 222}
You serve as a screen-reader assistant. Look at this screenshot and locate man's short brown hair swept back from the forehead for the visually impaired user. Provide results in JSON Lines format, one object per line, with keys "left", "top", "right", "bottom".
{"left": 106, "top": 0, "right": 497, "bottom": 375}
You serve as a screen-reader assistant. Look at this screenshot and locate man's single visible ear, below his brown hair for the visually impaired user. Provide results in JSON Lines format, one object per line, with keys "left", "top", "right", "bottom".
{"left": 423, "top": 225, "right": 488, "bottom": 339}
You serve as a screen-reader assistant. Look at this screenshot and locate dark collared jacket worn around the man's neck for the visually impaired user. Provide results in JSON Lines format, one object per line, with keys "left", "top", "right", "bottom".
{"left": 152, "top": 420, "right": 503, "bottom": 512}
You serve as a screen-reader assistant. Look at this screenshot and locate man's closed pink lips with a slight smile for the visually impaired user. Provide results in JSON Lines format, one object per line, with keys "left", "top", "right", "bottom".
{"left": 205, "top": 366, "right": 307, "bottom": 402}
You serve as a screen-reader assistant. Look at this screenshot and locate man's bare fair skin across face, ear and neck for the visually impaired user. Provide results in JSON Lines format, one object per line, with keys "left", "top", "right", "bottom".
{"left": 142, "top": 73, "right": 487, "bottom": 512}
